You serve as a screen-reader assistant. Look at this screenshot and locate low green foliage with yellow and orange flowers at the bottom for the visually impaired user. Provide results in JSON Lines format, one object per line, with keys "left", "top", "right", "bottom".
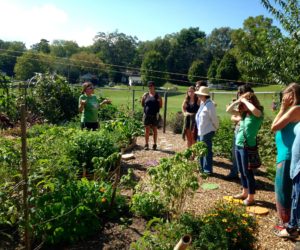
{"left": 130, "top": 203, "right": 257, "bottom": 250}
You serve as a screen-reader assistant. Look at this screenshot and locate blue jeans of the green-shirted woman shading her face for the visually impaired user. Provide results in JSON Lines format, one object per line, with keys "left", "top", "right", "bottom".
{"left": 235, "top": 146, "right": 255, "bottom": 194}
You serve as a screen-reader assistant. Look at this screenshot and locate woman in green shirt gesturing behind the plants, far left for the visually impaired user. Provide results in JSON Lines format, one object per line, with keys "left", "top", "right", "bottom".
{"left": 78, "top": 82, "right": 111, "bottom": 131}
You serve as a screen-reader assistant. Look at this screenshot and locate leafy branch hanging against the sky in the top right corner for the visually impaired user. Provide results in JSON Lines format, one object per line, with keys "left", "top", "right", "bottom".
{"left": 261, "top": 0, "right": 300, "bottom": 41}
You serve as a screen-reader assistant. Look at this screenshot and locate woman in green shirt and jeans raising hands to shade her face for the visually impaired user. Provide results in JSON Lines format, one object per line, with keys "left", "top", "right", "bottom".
{"left": 226, "top": 92, "right": 263, "bottom": 206}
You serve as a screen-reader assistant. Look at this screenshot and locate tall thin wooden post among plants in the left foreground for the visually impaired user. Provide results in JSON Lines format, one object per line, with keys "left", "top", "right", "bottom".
{"left": 21, "top": 104, "right": 30, "bottom": 250}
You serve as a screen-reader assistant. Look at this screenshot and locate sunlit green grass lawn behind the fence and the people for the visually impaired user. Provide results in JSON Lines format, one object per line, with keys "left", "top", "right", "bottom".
{"left": 96, "top": 85, "right": 282, "bottom": 118}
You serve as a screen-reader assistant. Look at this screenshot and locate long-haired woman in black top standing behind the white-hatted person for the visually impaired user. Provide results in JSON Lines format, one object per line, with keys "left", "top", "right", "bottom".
{"left": 182, "top": 86, "right": 200, "bottom": 147}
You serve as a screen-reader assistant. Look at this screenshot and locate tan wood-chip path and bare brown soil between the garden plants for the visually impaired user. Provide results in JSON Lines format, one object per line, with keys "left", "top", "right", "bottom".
{"left": 69, "top": 130, "right": 300, "bottom": 250}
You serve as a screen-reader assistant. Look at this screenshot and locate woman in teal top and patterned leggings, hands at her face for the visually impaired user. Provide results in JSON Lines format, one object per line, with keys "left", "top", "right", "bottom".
{"left": 271, "top": 83, "right": 300, "bottom": 236}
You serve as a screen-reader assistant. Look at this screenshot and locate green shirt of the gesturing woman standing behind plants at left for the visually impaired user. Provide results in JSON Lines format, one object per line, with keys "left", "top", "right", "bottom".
{"left": 79, "top": 95, "right": 99, "bottom": 122}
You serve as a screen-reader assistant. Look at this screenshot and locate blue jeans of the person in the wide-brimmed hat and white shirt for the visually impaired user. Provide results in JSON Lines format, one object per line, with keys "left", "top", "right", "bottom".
{"left": 198, "top": 131, "right": 215, "bottom": 174}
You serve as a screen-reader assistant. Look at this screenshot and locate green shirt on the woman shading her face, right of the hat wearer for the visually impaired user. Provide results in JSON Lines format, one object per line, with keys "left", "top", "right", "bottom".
{"left": 235, "top": 114, "right": 264, "bottom": 147}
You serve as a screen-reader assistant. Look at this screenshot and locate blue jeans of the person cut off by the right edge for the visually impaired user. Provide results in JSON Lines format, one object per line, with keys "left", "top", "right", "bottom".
{"left": 288, "top": 173, "right": 300, "bottom": 228}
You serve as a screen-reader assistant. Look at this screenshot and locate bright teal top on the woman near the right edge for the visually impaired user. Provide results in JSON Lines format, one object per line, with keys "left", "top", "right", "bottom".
{"left": 275, "top": 122, "right": 297, "bottom": 163}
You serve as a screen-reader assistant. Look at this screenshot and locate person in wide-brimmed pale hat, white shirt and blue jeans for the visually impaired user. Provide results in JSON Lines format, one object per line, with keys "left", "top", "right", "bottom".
{"left": 195, "top": 86, "right": 219, "bottom": 175}
